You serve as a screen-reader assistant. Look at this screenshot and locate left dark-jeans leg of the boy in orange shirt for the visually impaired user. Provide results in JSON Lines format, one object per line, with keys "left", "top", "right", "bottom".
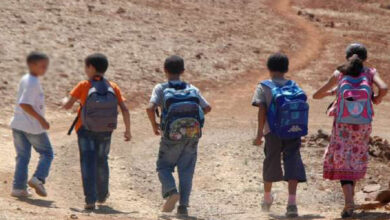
{"left": 77, "top": 128, "right": 97, "bottom": 204}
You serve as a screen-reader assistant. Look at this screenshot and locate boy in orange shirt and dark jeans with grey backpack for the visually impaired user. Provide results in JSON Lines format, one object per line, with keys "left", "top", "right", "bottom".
{"left": 64, "top": 53, "right": 131, "bottom": 210}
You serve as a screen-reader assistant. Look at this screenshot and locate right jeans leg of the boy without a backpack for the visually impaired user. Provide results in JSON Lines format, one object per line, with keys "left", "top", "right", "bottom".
{"left": 27, "top": 133, "right": 54, "bottom": 183}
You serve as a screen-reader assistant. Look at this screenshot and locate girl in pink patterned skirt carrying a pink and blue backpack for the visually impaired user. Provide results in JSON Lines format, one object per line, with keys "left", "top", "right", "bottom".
{"left": 313, "top": 43, "right": 387, "bottom": 218}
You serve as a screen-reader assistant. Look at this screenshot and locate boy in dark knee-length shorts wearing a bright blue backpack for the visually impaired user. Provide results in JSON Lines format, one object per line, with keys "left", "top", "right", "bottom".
{"left": 252, "top": 53, "right": 309, "bottom": 218}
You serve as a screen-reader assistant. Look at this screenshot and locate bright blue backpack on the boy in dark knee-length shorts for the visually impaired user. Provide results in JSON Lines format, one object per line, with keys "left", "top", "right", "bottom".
{"left": 261, "top": 80, "right": 309, "bottom": 139}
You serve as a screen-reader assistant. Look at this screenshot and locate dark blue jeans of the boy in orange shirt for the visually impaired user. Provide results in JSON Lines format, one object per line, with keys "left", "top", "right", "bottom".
{"left": 77, "top": 128, "right": 112, "bottom": 204}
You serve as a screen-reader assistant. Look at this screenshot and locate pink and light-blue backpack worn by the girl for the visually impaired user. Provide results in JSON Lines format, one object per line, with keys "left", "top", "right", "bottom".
{"left": 335, "top": 69, "right": 374, "bottom": 124}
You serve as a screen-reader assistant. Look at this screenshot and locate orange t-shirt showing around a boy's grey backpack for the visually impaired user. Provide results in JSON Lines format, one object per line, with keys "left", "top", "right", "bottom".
{"left": 70, "top": 80, "right": 125, "bottom": 131}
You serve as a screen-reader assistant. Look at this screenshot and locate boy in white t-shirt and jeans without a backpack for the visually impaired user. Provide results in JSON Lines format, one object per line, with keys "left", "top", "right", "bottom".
{"left": 11, "top": 52, "right": 53, "bottom": 197}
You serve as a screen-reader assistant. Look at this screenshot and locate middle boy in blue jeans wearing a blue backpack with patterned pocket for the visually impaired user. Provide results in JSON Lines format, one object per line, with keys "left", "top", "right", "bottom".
{"left": 147, "top": 56, "right": 211, "bottom": 216}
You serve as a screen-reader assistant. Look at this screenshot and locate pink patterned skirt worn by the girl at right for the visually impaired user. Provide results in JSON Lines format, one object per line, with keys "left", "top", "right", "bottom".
{"left": 324, "top": 122, "right": 372, "bottom": 180}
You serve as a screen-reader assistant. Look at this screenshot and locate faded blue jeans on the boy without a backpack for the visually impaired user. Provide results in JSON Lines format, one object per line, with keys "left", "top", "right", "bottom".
{"left": 12, "top": 129, "right": 54, "bottom": 189}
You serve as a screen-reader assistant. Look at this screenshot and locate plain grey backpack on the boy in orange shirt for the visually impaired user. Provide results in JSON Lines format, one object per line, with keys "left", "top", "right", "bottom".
{"left": 80, "top": 78, "right": 118, "bottom": 132}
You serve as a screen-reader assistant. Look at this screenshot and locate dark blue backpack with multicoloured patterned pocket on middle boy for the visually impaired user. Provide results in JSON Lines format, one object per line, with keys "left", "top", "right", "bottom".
{"left": 161, "top": 82, "right": 204, "bottom": 141}
